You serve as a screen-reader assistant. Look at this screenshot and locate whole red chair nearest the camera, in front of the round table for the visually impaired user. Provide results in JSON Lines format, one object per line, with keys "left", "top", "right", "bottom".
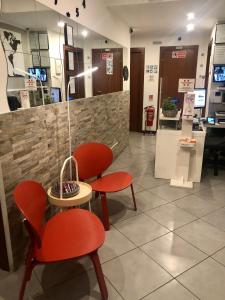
{"left": 13, "top": 181, "right": 108, "bottom": 300}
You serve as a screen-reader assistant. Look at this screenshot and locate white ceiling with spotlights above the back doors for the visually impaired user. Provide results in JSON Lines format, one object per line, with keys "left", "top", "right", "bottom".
{"left": 105, "top": 0, "right": 225, "bottom": 38}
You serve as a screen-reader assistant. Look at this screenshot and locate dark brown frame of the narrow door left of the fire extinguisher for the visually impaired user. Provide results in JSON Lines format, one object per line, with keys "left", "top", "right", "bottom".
{"left": 129, "top": 47, "right": 145, "bottom": 132}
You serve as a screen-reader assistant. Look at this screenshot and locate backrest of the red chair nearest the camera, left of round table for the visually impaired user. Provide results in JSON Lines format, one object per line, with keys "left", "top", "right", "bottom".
{"left": 13, "top": 181, "right": 47, "bottom": 240}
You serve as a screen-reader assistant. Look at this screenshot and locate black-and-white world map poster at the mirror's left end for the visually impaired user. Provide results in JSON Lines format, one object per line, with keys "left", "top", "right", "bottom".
{"left": 0, "top": 29, "right": 25, "bottom": 77}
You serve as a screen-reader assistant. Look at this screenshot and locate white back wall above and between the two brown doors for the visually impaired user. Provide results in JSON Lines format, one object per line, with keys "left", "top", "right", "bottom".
{"left": 131, "top": 36, "right": 210, "bottom": 130}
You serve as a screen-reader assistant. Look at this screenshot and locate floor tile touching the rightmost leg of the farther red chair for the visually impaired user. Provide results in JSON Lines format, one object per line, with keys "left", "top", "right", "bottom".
{"left": 135, "top": 190, "right": 167, "bottom": 211}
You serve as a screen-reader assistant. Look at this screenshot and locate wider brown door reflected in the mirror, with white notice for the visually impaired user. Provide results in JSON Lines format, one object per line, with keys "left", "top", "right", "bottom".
{"left": 92, "top": 48, "right": 123, "bottom": 96}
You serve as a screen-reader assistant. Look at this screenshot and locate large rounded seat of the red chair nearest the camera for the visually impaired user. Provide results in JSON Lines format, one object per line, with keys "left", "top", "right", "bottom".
{"left": 35, "top": 209, "right": 105, "bottom": 263}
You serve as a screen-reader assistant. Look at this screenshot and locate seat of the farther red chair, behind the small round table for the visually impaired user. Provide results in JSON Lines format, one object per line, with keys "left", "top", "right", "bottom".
{"left": 91, "top": 172, "right": 133, "bottom": 193}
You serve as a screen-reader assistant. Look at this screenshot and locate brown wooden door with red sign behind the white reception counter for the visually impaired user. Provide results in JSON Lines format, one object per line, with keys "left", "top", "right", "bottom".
{"left": 159, "top": 46, "right": 198, "bottom": 108}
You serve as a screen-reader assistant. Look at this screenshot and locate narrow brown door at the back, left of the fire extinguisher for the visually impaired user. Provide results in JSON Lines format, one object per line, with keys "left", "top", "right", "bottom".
{"left": 130, "top": 48, "right": 145, "bottom": 132}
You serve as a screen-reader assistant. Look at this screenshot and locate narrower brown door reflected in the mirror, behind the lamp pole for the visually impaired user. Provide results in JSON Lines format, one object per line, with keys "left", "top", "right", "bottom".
{"left": 64, "top": 45, "right": 85, "bottom": 99}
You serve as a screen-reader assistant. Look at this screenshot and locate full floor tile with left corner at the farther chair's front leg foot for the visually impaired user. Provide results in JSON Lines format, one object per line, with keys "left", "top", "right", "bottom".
{"left": 114, "top": 214, "right": 168, "bottom": 246}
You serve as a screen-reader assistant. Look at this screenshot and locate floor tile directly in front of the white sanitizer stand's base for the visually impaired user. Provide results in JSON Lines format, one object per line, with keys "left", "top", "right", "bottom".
{"left": 151, "top": 184, "right": 192, "bottom": 202}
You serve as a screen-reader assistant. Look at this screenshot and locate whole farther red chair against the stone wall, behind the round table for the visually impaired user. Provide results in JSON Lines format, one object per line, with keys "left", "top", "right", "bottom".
{"left": 73, "top": 143, "right": 137, "bottom": 230}
